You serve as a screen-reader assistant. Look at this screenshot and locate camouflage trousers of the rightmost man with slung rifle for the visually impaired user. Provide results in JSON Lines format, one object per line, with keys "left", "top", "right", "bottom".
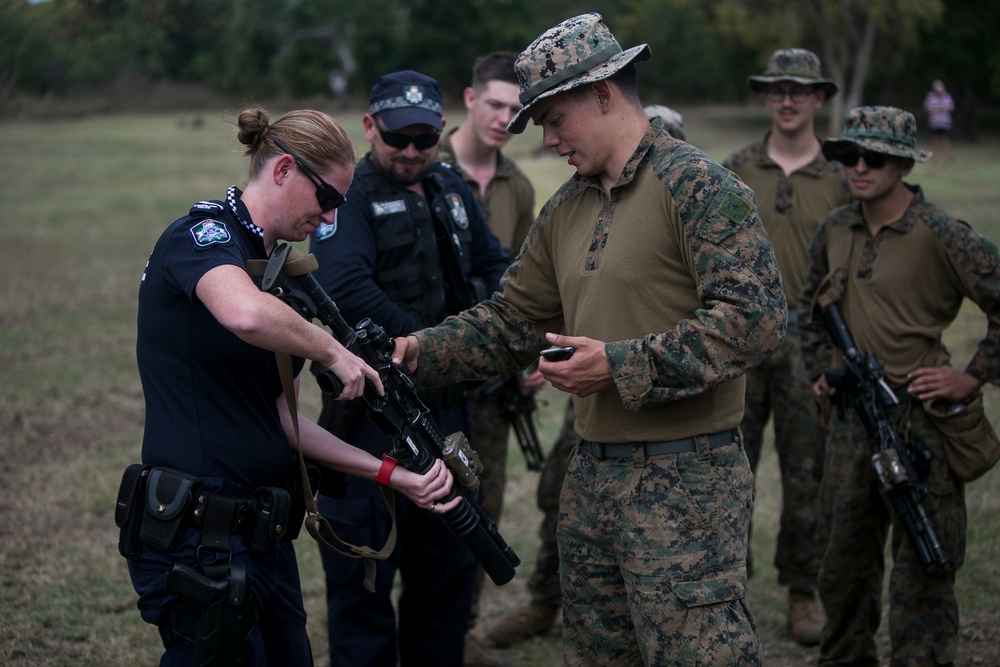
{"left": 819, "top": 405, "right": 966, "bottom": 667}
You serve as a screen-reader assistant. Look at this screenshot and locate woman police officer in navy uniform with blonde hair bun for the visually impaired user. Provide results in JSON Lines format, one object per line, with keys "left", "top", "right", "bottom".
{"left": 123, "top": 108, "right": 452, "bottom": 665}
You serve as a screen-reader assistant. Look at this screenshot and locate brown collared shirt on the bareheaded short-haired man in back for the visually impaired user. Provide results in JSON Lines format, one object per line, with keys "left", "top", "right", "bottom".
{"left": 437, "top": 128, "right": 535, "bottom": 257}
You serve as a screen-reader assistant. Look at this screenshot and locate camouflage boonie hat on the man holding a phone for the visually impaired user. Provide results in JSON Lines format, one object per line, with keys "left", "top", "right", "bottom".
{"left": 507, "top": 13, "right": 650, "bottom": 134}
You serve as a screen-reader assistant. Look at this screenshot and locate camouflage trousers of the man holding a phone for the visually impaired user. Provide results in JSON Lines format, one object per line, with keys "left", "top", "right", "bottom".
{"left": 558, "top": 436, "right": 760, "bottom": 667}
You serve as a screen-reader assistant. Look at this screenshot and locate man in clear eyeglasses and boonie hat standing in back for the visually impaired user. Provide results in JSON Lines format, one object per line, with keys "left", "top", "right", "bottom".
{"left": 722, "top": 49, "right": 850, "bottom": 646}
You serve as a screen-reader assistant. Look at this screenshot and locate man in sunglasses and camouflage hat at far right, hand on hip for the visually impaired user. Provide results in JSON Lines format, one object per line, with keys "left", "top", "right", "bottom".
{"left": 799, "top": 106, "right": 1000, "bottom": 667}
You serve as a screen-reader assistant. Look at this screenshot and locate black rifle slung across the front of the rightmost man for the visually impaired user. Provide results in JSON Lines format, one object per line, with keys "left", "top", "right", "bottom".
{"left": 823, "top": 303, "right": 948, "bottom": 572}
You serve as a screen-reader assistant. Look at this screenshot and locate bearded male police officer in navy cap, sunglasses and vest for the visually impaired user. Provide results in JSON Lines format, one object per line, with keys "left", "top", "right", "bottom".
{"left": 312, "top": 70, "right": 510, "bottom": 667}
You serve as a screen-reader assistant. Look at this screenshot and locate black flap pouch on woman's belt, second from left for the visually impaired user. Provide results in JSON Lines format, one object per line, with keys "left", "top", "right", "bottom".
{"left": 140, "top": 468, "right": 199, "bottom": 550}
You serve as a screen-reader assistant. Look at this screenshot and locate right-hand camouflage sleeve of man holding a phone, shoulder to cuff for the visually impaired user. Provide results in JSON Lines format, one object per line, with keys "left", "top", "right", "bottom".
{"left": 606, "top": 166, "right": 787, "bottom": 410}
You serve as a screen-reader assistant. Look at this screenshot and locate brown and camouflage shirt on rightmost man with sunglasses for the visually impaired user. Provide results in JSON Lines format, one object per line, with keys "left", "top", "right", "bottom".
{"left": 799, "top": 186, "right": 1000, "bottom": 387}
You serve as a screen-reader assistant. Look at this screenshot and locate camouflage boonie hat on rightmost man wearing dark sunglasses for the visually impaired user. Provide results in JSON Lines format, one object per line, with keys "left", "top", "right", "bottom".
{"left": 823, "top": 107, "right": 931, "bottom": 162}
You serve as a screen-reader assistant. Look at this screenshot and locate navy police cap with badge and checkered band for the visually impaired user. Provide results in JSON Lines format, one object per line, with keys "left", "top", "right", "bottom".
{"left": 368, "top": 69, "right": 442, "bottom": 130}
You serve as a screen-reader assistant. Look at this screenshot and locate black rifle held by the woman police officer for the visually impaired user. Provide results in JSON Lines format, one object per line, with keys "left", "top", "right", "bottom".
{"left": 261, "top": 243, "right": 521, "bottom": 585}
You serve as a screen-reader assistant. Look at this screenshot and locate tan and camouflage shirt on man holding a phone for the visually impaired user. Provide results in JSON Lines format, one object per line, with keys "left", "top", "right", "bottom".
{"left": 417, "top": 121, "right": 786, "bottom": 442}
